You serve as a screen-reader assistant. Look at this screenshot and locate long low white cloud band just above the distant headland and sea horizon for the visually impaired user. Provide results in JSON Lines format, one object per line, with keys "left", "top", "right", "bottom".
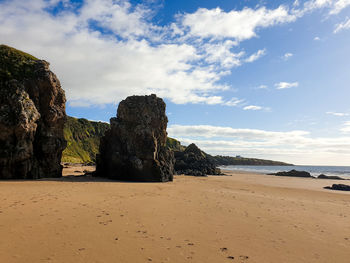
{"left": 168, "top": 125, "right": 350, "bottom": 165}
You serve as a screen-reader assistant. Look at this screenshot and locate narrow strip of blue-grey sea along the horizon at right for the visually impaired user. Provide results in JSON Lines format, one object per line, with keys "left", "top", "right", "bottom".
{"left": 219, "top": 165, "right": 350, "bottom": 179}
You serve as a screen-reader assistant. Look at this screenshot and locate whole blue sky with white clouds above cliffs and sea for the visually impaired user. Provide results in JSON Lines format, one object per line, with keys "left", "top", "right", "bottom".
{"left": 0, "top": 0, "right": 350, "bottom": 166}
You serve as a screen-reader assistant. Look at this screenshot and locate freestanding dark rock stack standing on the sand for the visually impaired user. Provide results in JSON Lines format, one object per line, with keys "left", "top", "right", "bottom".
{"left": 96, "top": 94, "right": 175, "bottom": 182}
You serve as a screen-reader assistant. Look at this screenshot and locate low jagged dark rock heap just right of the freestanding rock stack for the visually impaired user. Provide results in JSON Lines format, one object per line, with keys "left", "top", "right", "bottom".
{"left": 175, "top": 143, "right": 221, "bottom": 176}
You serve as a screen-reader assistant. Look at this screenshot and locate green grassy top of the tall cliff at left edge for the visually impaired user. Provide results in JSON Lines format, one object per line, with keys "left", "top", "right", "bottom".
{"left": 0, "top": 45, "right": 39, "bottom": 81}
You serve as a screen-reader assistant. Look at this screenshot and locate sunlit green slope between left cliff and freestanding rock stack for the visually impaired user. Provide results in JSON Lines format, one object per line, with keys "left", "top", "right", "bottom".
{"left": 62, "top": 117, "right": 109, "bottom": 163}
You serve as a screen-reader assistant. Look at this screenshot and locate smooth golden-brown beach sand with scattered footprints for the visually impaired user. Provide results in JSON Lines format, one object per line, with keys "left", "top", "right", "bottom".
{"left": 0, "top": 167, "right": 350, "bottom": 263}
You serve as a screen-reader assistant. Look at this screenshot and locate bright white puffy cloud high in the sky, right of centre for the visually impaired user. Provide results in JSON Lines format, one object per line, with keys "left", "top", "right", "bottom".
{"left": 180, "top": 6, "right": 296, "bottom": 41}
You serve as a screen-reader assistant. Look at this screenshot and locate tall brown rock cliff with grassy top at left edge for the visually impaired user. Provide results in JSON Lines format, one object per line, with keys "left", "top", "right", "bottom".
{"left": 0, "top": 45, "right": 66, "bottom": 179}
